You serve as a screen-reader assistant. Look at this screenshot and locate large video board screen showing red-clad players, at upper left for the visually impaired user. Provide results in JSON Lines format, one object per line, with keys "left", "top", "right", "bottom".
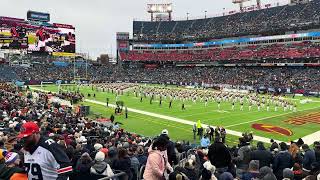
{"left": 0, "top": 18, "right": 76, "bottom": 56}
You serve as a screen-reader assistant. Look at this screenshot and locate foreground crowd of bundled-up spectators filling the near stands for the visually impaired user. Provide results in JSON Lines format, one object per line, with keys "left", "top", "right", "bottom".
{"left": 0, "top": 84, "right": 320, "bottom": 180}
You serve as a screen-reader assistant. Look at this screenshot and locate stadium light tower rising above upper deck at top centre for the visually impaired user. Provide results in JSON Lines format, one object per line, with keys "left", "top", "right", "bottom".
{"left": 147, "top": 3, "right": 173, "bottom": 21}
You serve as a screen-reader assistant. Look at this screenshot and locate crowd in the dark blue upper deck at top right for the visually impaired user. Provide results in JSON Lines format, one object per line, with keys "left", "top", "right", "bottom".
{"left": 133, "top": 0, "right": 320, "bottom": 41}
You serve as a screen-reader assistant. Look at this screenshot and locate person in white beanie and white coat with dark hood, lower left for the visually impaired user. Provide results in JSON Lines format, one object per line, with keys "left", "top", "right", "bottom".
{"left": 90, "top": 151, "right": 114, "bottom": 177}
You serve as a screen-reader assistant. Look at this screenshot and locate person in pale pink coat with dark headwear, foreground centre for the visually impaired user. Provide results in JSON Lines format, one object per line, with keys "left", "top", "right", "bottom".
{"left": 143, "top": 136, "right": 169, "bottom": 180}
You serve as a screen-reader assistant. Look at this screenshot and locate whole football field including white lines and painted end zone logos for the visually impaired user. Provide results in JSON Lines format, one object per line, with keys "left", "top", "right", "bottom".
{"left": 31, "top": 85, "right": 320, "bottom": 145}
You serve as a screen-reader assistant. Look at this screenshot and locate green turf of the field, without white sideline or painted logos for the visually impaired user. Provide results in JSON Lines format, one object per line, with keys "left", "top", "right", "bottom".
{"left": 31, "top": 85, "right": 320, "bottom": 144}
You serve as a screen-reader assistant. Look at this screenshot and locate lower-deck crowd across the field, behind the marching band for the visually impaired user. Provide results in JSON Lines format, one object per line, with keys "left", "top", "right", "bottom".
{"left": 0, "top": 62, "right": 320, "bottom": 92}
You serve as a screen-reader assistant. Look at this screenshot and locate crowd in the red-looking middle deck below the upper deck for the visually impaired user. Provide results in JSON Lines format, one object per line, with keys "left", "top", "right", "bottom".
{"left": 121, "top": 41, "right": 320, "bottom": 62}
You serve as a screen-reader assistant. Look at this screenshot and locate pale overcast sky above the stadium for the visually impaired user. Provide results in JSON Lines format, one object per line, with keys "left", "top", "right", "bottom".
{"left": 0, "top": 0, "right": 287, "bottom": 58}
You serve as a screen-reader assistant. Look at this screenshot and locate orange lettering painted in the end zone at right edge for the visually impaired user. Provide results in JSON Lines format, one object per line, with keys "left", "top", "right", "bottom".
{"left": 284, "top": 112, "right": 320, "bottom": 126}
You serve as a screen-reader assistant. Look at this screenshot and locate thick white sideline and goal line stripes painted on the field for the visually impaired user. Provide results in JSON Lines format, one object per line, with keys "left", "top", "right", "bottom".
{"left": 32, "top": 87, "right": 320, "bottom": 145}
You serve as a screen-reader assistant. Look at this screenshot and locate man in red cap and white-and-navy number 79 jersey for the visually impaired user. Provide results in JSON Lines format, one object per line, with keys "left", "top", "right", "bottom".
{"left": 18, "top": 122, "right": 72, "bottom": 180}
